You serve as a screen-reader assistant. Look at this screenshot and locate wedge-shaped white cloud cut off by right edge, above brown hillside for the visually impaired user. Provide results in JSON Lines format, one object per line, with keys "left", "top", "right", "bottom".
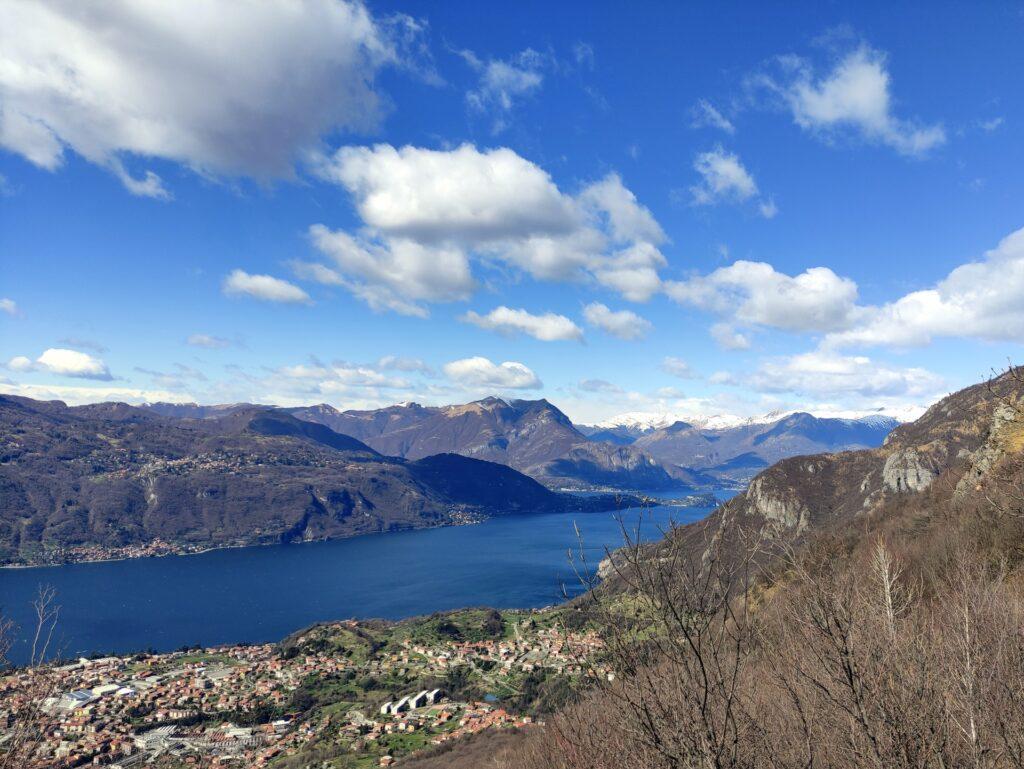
{"left": 825, "top": 228, "right": 1024, "bottom": 347}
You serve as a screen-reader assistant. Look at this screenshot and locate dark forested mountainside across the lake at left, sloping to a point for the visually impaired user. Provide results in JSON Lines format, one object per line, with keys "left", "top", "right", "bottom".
{"left": 0, "top": 396, "right": 617, "bottom": 561}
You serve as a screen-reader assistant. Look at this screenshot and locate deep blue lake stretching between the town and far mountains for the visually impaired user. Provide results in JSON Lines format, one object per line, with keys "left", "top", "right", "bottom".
{"left": 0, "top": 493, "right": 724, "bottom": 663}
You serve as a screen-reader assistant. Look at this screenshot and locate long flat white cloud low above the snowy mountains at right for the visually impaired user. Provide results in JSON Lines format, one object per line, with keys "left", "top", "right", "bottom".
{"left": 749, "top": 350, "right": 944, "bottom": 398}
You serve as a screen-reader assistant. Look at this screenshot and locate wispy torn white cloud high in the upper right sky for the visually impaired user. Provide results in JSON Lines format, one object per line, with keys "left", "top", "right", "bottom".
{"left": 762, "top": 45, "right": 946, "bottom": 156}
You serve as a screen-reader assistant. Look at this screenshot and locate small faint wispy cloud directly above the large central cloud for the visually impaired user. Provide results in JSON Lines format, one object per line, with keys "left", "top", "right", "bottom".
{"left": 459, "top": 48, "right": 549, "bottom": 133}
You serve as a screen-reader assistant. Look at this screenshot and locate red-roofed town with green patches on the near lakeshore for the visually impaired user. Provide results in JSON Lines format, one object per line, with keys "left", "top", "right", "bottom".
{"left": 0, "top": 608, "right": 611, "bottom": 769}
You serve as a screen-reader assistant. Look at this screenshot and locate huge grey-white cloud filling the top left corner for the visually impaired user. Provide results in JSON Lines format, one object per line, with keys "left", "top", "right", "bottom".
{"left": 0, "top": 0, "right": 413, "bottom": 198}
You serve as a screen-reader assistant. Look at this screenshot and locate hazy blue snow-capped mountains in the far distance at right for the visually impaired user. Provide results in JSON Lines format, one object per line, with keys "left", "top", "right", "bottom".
{"left": 614, "top": 414, "right": 898, "bottom": 481}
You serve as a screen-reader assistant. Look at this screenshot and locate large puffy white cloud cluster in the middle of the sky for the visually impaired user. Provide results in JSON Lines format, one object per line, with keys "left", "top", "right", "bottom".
{"left": 307, "top": 144, "right": 666, "bottom": 315}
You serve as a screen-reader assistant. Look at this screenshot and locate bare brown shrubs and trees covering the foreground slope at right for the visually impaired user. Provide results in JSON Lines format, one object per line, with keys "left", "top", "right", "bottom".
{"left": 508, "top": 370, "right": 1024, "bottom": 769}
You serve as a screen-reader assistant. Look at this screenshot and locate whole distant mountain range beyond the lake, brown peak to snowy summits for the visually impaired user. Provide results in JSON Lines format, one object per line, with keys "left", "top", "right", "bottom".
{"left": 142, "top": 397, "right": 905, "bottom": 489}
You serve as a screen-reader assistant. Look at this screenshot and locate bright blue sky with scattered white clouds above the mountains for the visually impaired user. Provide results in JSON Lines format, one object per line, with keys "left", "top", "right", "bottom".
{"left": 0, "top": 0, "right": 1024, "bottom": 421}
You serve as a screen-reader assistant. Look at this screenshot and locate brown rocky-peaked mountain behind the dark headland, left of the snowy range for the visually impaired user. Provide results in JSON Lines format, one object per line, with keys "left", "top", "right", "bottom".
{"left": 288, "top": 397, "right": 689, "bottom": 488}
